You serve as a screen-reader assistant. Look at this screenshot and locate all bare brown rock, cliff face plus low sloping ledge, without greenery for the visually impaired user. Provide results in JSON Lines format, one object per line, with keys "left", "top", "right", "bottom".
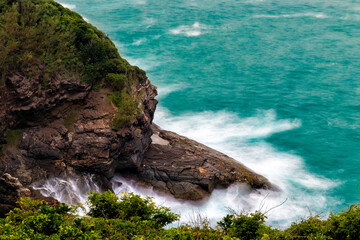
{"left": 0, "top": 69, "right": 273, "bottom": 214}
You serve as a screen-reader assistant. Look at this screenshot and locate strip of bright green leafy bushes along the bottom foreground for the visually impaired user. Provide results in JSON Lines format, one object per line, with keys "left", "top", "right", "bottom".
{"left": 0, "top": 191, "right": 360, "bottom": 240}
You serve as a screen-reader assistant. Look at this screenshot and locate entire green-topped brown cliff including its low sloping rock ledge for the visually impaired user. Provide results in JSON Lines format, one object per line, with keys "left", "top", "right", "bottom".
{"left": 0, "top": 0, "right": 272, "bottom": 217}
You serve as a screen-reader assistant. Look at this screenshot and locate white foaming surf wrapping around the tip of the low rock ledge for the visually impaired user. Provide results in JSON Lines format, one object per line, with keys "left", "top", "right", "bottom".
{"left": 154, "top": 106, "right": 341, "bottom": 227}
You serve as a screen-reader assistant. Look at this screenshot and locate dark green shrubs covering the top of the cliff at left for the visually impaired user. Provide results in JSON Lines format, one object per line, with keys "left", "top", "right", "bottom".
{"left": 0, "top": 0, "right": 146, "bottom": 128}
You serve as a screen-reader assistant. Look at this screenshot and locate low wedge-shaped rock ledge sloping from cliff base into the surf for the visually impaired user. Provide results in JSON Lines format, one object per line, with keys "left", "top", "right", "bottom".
{"left": 140, "top": 125, "right": 274, "bottom": 200}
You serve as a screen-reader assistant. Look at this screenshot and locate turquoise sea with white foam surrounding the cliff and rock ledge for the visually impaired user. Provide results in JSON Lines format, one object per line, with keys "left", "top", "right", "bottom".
{"left": 57, "top": 0, "right": 360, "bottom": 225}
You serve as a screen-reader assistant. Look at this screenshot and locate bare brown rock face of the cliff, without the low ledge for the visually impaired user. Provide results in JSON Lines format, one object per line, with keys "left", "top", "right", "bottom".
{"left": 0, "top": 72, "right": 157, "bottom": 217}
